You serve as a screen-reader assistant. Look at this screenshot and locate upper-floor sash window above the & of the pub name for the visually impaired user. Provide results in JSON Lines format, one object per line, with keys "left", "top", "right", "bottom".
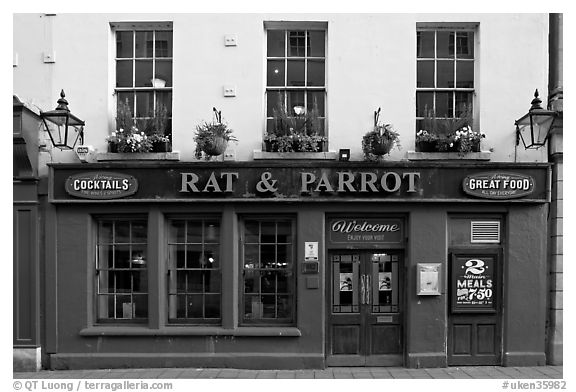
{"left": 265, "top": 22, "right": 327, "bottom": 149}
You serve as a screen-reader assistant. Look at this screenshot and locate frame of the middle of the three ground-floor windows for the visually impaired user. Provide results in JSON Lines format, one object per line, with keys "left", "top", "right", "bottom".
{"left": 165, "top": 215, "right": 224, "bottom": 326}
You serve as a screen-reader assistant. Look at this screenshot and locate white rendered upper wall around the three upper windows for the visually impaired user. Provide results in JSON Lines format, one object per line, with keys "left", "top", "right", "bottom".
{"left": 13, "top": 14, "right": 548, "bottom": 162}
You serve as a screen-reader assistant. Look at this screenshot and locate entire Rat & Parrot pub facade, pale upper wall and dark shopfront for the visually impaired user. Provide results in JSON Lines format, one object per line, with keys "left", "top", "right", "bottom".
{"left": 14, "top": 14, "right": 557, "bottom": 369}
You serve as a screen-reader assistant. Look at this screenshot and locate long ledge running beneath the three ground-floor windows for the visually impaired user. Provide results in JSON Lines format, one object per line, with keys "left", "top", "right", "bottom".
{"left": 80, "top": 325, "right": 302, "bottom": 337}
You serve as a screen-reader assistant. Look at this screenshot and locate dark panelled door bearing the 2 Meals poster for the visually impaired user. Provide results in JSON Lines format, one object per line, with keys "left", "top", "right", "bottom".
{"left": 448, "top": 251, "right": 502, "bottom": 366}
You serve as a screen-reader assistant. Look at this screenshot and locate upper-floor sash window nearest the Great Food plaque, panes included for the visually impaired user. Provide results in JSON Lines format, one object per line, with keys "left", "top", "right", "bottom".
{"left": 416, "top": 26, "right": 475, "bottom": 150}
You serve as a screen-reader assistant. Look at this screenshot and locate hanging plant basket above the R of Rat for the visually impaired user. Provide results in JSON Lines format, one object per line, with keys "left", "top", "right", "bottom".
{"left": 194, "top": 108, "right": 237, "bottom": 160}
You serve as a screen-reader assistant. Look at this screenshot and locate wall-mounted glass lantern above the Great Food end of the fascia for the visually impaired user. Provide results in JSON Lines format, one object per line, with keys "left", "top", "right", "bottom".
{"left": 514, "top": 90, "right": 557, "bottom": 150}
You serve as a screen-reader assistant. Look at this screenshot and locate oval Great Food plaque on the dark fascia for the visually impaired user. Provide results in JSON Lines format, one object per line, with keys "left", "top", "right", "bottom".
{"left": 463, "top": 172, "right": 534, "bottom": 199}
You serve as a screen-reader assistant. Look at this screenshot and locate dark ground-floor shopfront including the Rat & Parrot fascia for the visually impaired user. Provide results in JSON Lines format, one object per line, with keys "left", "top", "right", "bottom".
{"left": 46, "top": 162, "right": 548, "bottom": 368}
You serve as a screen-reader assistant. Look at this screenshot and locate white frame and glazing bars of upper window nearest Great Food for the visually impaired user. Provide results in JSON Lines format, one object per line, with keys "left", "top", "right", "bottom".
{"left": 415, "top": 23, "right": 479, "bottom": 132}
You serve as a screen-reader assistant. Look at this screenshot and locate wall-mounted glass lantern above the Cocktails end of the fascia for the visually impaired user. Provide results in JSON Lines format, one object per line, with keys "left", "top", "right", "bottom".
{"left": 40, "top": 90, "right": 84, "bottom": 150}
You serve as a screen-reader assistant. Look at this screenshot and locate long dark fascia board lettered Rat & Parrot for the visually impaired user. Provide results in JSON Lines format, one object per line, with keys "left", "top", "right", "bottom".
{"left": 50, "top": 162, "right": 549, "bottom": 203}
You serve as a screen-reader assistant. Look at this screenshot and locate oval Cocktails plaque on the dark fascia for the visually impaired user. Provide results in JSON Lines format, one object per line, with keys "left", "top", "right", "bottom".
{"left": 65, "top": 172, "right": 138, "bottom": 200}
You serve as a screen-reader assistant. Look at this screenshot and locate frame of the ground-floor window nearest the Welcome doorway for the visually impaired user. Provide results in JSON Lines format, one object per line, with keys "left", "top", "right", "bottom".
{"left": 237, "top": 215, "right": 298, "bottom": 327}
